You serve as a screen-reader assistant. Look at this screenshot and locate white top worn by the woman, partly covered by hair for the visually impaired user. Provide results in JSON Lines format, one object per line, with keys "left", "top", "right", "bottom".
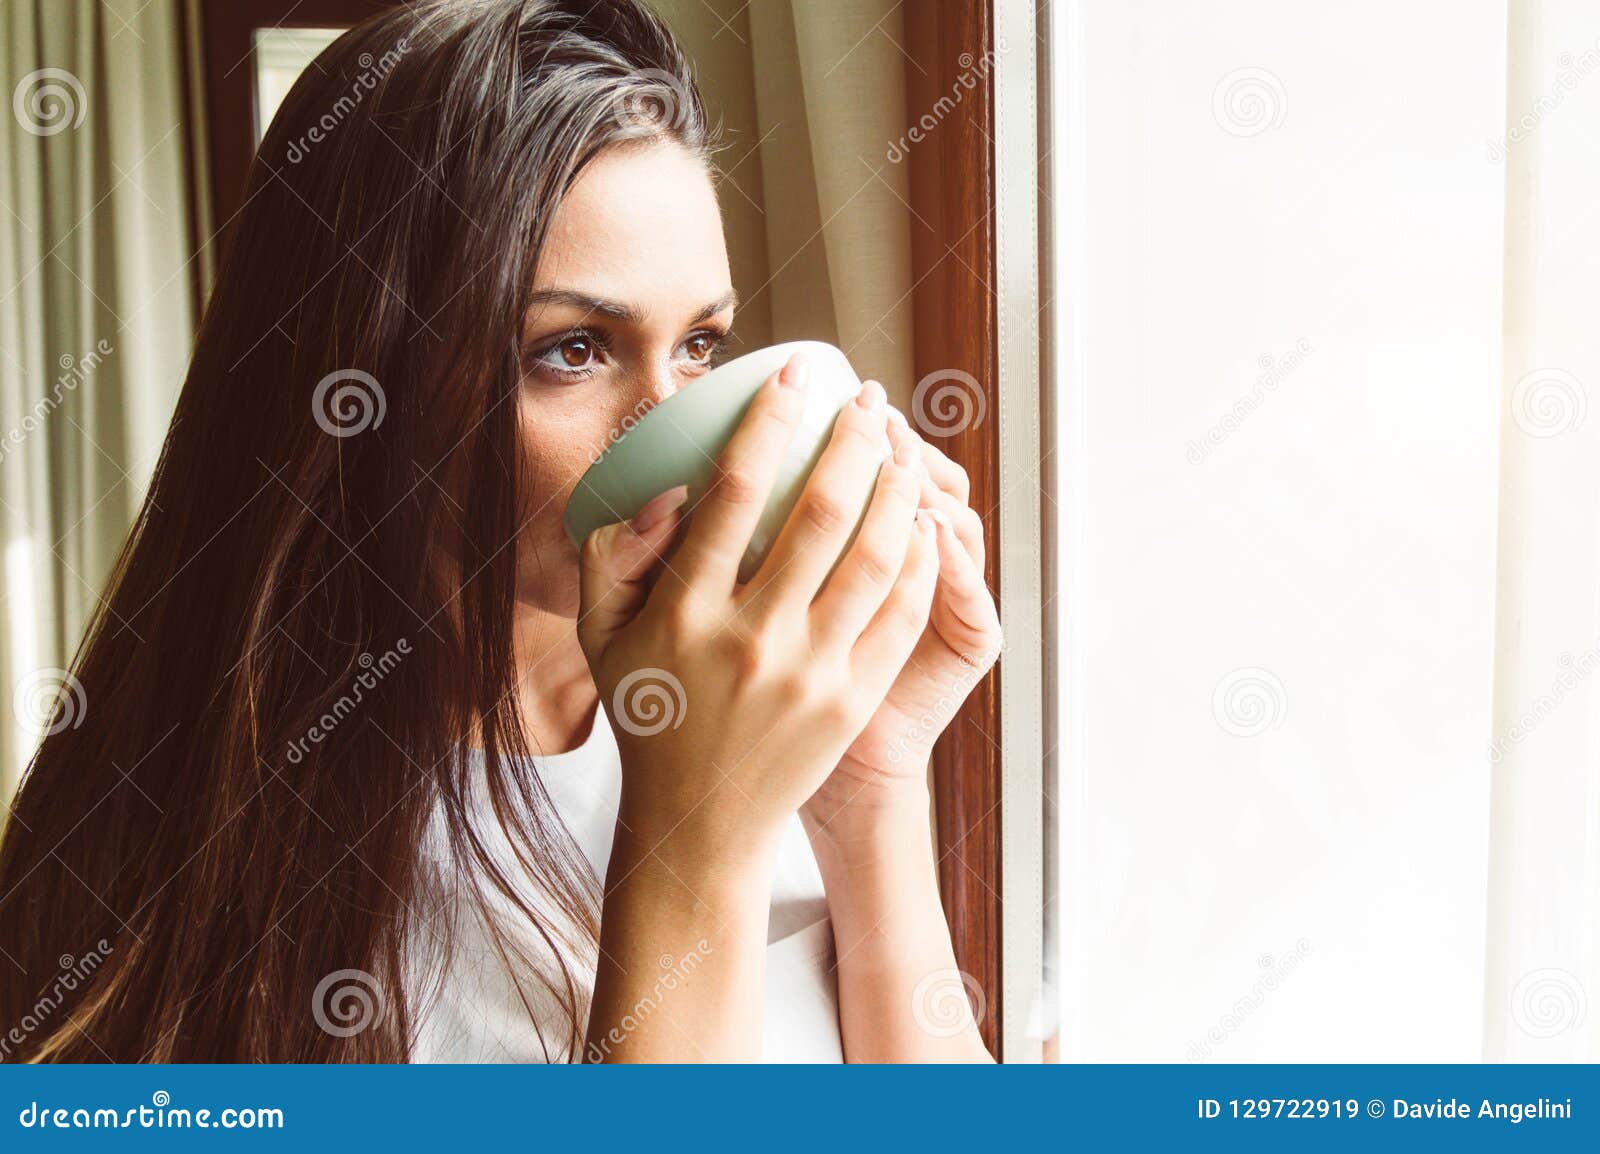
{"left": 410, "top": 707, "right": 843, "bottom": 1063}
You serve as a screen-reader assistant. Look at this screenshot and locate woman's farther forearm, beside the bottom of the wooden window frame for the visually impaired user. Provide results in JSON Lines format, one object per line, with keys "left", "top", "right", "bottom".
{"left": 806, "top": 768, "right": 992, "bottom": 1063}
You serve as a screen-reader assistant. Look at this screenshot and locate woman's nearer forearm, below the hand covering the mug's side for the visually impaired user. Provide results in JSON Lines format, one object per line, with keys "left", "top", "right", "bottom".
{"left": 584, "top": 826, "right": 771, "bottom": 1063}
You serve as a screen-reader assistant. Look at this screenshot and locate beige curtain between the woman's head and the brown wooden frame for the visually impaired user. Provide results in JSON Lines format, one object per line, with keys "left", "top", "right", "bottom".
{"left": 656, "top": 0, "right": 915, "bottom": 407}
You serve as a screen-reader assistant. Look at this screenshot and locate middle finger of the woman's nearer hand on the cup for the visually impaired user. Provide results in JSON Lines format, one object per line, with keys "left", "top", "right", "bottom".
{"left": 750, "top": 381, "right": 888, "bottom": 605}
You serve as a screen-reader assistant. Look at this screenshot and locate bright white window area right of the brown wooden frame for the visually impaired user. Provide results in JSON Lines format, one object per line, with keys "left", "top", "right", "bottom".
{"left": 1046, "top": 0, "right": 1600, "bottom": 1063}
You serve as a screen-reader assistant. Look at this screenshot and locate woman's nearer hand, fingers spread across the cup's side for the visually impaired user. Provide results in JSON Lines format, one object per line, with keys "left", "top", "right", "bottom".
{"left": 578, "top": 355, "right": 939, "bottom": 856}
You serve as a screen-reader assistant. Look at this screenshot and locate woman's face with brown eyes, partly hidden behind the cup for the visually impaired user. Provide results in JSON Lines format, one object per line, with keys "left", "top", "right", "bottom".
{"left": 517, "top": 144, "right": 734, "bottom": 618}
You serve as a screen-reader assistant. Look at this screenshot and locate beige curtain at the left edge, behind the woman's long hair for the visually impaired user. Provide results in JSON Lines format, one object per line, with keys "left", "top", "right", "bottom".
{"left": 0, "top": 0, "right": 194, "bottom": 793}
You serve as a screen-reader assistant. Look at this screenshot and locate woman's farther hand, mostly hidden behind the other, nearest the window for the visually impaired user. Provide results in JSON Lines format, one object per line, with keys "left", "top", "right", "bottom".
{"left": 806, "top": 398, "right": 1002, "bottom": 832}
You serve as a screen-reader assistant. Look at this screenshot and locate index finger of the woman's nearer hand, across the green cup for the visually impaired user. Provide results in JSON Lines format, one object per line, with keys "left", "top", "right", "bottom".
{"left": 672, "top": 352, "right": 811, "bottom": 591}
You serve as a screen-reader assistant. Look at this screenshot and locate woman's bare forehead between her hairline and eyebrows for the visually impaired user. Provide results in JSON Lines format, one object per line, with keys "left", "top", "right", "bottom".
{"left": 534, "top": 142, "right": 731, "bottom": 317}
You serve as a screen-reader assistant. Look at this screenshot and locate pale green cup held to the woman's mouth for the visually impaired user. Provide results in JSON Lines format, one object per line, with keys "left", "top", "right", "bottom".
{"left": 563, "top": 341, "right": 890, "bottom": 581}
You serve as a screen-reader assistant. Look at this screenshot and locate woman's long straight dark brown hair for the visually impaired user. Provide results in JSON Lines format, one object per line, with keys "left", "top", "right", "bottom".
{"left": 0, "top": 0, "right": 706, "bottom": 1061}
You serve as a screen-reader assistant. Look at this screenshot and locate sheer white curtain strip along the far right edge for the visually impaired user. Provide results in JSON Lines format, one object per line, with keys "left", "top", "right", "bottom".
{"left": 1485, "top": 0, "right": 1600, "bottom": 1061}
